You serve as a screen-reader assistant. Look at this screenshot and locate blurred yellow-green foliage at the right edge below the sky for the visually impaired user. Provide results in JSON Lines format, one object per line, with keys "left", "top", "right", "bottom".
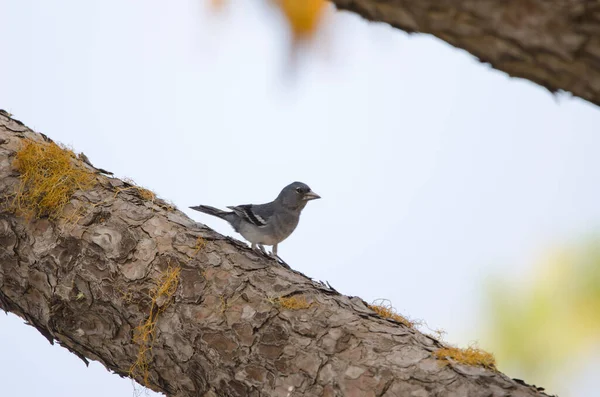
{"left": 485, "top": 239, "right": 600, "bottom": 390}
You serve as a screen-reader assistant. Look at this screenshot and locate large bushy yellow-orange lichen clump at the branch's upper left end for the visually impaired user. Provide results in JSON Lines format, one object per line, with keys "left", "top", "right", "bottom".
{"left": 11, "top": 140, "right": 95, "bottom": 219}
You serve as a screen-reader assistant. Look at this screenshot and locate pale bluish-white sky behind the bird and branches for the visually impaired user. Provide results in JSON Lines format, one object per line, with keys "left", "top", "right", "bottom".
{"left": 0, "top": 0, "right": 600, "bottom": 397}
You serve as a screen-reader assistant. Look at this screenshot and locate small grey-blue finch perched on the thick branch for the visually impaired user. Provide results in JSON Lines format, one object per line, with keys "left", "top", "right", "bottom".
{"left": 190, "top": 182, "right": 321, "bottom": 263}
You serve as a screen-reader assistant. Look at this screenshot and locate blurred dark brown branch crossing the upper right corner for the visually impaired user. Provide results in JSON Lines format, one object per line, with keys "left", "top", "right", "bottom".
{"left": 333, "top": 0, "right": 600, "bottom": 105}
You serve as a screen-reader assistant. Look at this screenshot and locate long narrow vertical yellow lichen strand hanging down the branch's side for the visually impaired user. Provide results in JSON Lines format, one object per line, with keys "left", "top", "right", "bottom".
{"left": 129, "top": 265, "right": 181, "bottom": 387}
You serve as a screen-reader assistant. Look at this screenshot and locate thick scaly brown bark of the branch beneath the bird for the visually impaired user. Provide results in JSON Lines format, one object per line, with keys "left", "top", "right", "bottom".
{"left": 0, "top": 112, "right": 545, "bottom": 397}
